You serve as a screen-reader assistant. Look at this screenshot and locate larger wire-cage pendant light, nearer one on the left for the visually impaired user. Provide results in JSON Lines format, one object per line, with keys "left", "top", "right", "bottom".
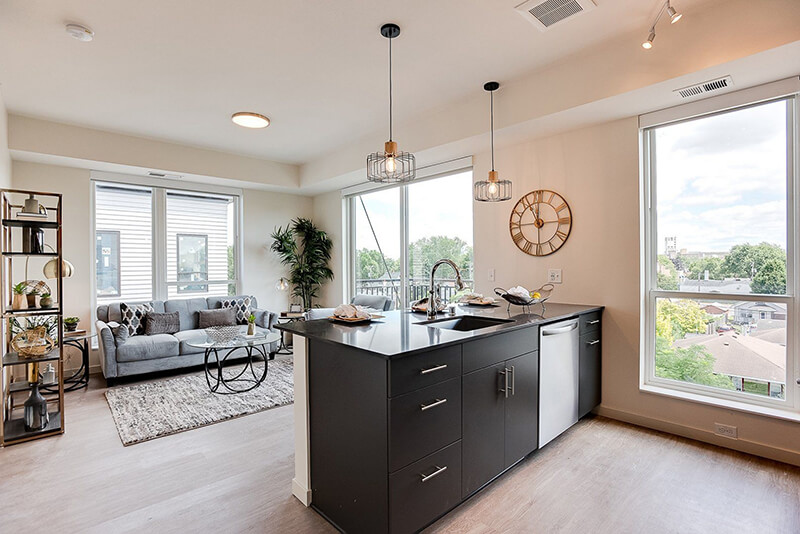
{"left": 367, "top": 24, "right": 417, "bottom": 184}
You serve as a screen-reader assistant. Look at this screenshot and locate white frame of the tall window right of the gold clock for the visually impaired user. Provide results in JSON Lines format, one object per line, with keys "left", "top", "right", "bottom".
{"left": 639, "top": 78, "right": 800, "bottom": 420}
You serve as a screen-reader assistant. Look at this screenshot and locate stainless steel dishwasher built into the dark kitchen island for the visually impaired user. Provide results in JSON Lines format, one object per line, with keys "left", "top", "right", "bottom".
{"left": 539, "top": 319, "right": 579, "bottom": 447}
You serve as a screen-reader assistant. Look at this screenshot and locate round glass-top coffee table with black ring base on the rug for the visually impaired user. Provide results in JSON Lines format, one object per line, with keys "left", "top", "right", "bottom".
{"left": 188, "top": 334, "right": 281, "bottom": 395}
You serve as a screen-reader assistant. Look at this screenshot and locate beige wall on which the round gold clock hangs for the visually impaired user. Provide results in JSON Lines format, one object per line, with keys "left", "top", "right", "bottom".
{"left": 474, "top": 118, "right": 800, "bottom": 465}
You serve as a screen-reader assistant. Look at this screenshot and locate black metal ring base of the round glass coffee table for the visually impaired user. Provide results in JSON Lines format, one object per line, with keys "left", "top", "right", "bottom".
{"left": 204, "top": 345, "right": 269, "bottom": 395}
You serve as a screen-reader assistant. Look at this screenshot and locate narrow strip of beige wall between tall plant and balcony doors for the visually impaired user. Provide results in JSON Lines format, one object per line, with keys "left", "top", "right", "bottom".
{"left": 314, "top": 191, "right": 346, "bottom": 307}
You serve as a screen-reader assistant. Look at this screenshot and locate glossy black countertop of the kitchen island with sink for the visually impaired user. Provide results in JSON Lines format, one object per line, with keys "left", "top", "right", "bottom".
{"left": 276, "top": 303, "right": 603, "bottom": 357}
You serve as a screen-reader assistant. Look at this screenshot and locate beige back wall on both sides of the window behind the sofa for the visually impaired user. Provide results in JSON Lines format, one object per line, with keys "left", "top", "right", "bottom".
{"left": 13, "top": 161, "right": 312, "bottom": 372}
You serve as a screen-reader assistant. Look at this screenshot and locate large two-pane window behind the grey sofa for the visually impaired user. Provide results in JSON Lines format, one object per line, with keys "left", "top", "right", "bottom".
{"left": 95, "top": 182, "right": 238, "bottom": 303}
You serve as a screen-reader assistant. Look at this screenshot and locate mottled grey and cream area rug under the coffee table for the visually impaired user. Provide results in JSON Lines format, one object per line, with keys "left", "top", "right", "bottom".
{"left": 106, "top": 360, "right": 293, "bottom": 446}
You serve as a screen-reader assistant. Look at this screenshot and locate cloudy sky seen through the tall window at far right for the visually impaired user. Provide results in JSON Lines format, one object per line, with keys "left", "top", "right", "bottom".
{"left": 656, "top": 101, "right": 787, "bottom": 253}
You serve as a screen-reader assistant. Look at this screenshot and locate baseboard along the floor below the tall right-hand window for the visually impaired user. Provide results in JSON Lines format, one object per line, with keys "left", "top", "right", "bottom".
{"left": 597, "top": 405, "right": 800, "bottom": 466}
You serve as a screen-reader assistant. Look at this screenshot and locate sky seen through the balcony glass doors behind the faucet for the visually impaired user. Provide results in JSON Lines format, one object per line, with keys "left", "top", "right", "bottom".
{"left": 356, "top": 171, "right": 472, "bottom": 259}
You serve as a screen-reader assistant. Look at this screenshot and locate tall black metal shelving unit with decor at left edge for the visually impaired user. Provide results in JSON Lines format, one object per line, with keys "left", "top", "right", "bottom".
{"left": 0, "top": 189, "right": 64, "bottom": 446}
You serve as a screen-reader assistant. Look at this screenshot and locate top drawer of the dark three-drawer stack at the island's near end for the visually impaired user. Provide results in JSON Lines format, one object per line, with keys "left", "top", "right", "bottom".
{"left": 389, "top": 345, "right": 461, "bottom": 397}
